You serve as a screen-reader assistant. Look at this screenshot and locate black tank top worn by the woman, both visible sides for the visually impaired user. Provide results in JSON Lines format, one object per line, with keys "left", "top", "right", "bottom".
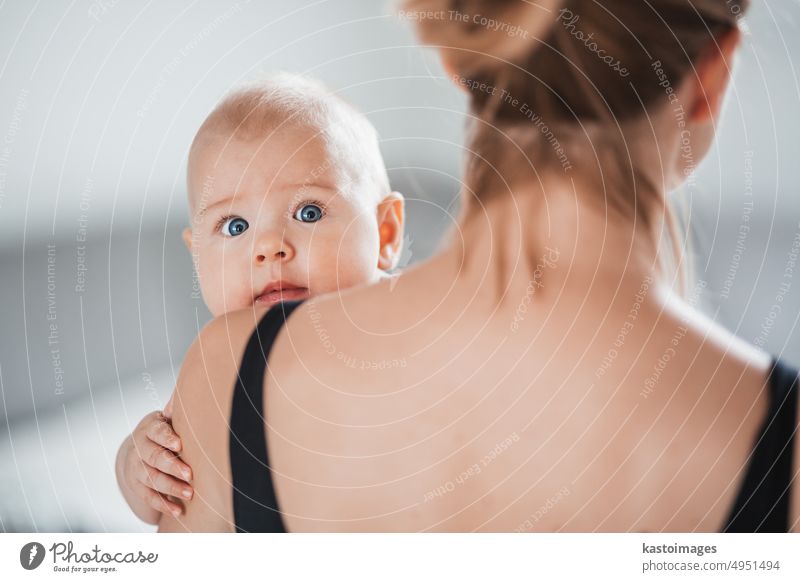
{"left": 229, "top": 301, "right": 798, "bottom": 532}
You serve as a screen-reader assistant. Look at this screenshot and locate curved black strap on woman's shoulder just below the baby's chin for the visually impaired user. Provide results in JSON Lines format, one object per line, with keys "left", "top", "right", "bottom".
{"left": 229, "top": 301, "right": 302, "bottom": 532}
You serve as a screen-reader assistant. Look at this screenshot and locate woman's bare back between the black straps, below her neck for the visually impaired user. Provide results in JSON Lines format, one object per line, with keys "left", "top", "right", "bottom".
{"left": 266, "top": 238, "right": 770, "bottom": 531}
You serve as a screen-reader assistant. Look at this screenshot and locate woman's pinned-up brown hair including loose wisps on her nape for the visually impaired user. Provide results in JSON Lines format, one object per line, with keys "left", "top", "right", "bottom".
{"left": 403, "top": 0, "right": 749, "bottom": 290}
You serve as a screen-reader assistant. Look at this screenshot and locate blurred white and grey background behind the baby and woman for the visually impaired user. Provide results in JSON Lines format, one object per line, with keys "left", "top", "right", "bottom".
{"left": 0, "top": 0, "right": 800, "bottom": 531}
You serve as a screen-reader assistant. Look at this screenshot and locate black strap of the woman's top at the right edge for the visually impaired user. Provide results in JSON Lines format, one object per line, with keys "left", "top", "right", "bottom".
{"left": 723, "top": 359, "right": 798, "bottom": 533}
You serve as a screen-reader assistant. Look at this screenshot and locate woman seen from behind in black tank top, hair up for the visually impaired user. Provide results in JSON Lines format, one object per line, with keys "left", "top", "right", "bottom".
{"left": 160, "top": 0, "right": 800, "bottom": 531}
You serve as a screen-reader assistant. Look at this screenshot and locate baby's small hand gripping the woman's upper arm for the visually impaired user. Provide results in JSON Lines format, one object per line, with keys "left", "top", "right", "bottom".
{"left": 124, "top": 408, "right": 194, "bottom": 517}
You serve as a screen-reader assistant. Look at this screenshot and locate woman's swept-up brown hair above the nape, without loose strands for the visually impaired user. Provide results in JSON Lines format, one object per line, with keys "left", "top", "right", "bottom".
{"left": 404, "top": 0, "right": 749, "bottom": 123}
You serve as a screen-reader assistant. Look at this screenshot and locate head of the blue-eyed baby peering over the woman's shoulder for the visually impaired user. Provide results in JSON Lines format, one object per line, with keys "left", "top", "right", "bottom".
{"left": 183, "top": 74, "right": 404, "bottom": 316}
